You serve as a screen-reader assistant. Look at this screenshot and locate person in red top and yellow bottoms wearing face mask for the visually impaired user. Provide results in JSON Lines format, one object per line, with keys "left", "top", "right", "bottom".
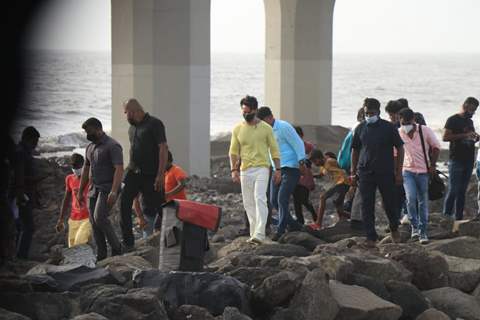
{"left": 55, "top": 153, "right": 92, "bottom": 247}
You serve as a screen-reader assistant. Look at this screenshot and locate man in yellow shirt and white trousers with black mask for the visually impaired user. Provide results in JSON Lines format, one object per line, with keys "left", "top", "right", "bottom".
{"left": 229, "top": 96, "right": 281, "bottom": 244}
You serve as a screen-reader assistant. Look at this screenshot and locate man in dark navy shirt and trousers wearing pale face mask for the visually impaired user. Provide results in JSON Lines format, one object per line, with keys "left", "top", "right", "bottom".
{"left": 351, "top": 98, "right": 404, "bottom": 247}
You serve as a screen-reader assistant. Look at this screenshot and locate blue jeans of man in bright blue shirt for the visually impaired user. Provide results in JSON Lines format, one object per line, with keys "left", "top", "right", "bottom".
{"left": 270, "top": 167, "right": 301, "bottom": 234}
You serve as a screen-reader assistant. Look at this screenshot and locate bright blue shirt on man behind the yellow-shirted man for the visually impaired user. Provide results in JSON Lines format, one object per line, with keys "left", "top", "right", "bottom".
{"left": 273, "top": 119, "right": 305, "bottom": 168}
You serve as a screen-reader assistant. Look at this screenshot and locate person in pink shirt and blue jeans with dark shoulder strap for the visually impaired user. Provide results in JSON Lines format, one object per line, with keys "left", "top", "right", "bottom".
{"left": 398, "top": 109, "right": 440, "bottom": 244}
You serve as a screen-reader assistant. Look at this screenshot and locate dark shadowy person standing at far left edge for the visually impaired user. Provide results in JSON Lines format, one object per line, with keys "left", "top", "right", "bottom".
{"left": 14, "top": 127, "right": 40, "bottom": 259}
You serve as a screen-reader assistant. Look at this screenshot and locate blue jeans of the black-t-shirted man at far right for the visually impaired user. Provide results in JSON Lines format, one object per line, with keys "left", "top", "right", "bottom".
{"left": 443, "top": 160, "right": 473, "bottom": 220}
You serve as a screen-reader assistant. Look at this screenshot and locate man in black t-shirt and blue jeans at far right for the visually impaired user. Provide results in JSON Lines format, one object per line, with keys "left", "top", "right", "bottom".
{"left": 443, "top": 97, "right": 479, "bottom": 220}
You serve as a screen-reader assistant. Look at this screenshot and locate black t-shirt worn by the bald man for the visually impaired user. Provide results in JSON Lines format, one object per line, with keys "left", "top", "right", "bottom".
{"left": 128, "top": 113, "right": 167, "bottom": 175}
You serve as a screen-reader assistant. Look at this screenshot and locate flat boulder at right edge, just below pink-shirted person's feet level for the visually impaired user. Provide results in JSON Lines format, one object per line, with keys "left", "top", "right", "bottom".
{"left": 425, "top": 237, "right": 480, "bottom": 259}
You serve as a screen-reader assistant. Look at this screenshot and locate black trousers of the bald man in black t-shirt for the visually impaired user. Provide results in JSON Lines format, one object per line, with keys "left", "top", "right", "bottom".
{"left": 120, "top": 170, "right": 165, "bottom": 247}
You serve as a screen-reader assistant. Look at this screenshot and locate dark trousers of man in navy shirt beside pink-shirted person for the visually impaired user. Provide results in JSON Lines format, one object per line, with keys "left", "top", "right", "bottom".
{"left": 359, "top": 173, "right": 399, "bottom": 241}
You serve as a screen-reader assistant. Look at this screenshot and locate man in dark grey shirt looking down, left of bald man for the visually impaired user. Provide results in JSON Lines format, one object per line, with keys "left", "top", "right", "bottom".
{"left": 77, "top": 118, "right": 123, "bottom": 261}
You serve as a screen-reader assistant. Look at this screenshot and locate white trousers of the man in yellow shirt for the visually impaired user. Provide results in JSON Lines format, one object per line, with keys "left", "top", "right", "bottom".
{"left": 240, "top": 167, "right": 270, "bottom": 240}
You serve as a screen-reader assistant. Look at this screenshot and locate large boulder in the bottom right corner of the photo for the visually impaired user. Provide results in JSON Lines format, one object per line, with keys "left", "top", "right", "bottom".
{"left": 423, "top": 287, "right": 480, "bottom": 320}
